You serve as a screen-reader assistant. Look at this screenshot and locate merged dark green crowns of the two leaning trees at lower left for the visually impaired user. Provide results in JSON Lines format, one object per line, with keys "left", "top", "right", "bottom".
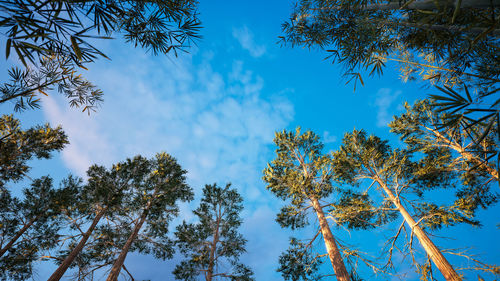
{"left": 62, "top": 153, "right": 193, "bottom": 278}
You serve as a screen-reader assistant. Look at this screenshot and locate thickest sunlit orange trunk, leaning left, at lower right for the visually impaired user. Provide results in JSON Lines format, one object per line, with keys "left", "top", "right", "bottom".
{"left": 376, "top": 177, "right": 462, "bottom": 281}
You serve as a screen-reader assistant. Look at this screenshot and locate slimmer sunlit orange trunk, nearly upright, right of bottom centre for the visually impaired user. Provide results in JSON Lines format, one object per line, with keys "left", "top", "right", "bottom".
{"left": 310, "top": 198, "right": 351, "bottom": 281}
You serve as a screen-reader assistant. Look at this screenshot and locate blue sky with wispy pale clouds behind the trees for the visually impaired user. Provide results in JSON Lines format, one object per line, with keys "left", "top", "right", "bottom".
{"left": 0, "top": 0, "right": 500, "bottom": 280}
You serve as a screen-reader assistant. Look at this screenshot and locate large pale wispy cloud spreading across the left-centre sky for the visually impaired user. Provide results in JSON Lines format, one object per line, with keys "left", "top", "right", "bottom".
{"left": 43, "top": 46, "right": 294, "bottom": 279}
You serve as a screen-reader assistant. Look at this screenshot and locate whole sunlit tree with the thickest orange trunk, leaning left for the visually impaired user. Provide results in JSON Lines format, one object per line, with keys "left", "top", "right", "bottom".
{"left": 332, "top": 130, "right": 486, "bottom": 280}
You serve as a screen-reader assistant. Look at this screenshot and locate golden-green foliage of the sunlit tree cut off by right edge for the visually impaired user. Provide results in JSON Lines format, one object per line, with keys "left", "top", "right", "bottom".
{"left": 389, "top": 100, "right": 498, "bottom": 212}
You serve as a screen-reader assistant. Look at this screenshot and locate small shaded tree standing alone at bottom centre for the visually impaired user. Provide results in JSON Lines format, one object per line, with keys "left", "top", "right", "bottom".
{"left": 173, "top": 184, "right": 254, "bottom": 281}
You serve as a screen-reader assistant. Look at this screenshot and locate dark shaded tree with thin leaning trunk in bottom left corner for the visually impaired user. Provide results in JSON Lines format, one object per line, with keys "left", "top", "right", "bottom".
{"left": 0, "top": 177, "right": 74, "bottom": 280}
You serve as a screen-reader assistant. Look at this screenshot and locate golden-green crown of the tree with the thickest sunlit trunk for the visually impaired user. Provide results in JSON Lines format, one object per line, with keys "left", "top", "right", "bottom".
{"left": 332, "top": 130, "right": 477, "bottom": 229}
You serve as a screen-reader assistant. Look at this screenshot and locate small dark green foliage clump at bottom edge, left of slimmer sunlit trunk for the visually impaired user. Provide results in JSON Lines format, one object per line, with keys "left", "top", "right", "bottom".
{"left": 277, "top": 238, "right": 321, "bottom": 281}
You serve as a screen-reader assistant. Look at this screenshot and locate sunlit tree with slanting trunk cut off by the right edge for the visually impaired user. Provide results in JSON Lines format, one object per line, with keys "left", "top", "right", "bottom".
{"left": 389, "top": 100, "right": 499, "bottom": 188}
